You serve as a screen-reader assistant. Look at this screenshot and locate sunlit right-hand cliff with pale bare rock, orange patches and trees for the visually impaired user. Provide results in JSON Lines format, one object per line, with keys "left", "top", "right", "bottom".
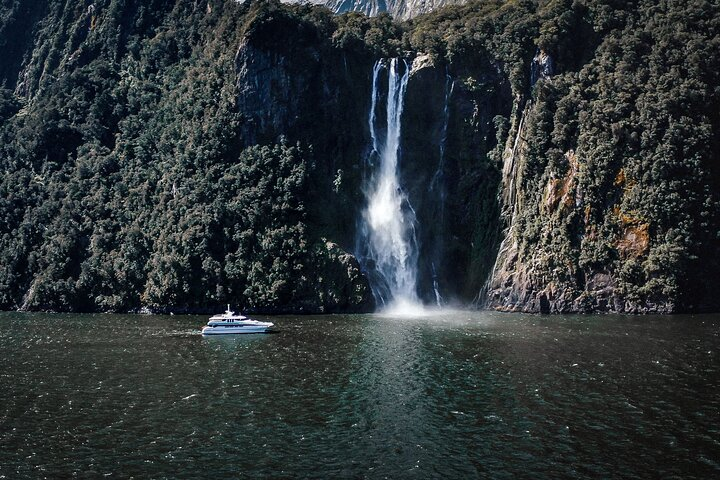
{"left": 485, "top": 15, "right": 720, "bottom": 313}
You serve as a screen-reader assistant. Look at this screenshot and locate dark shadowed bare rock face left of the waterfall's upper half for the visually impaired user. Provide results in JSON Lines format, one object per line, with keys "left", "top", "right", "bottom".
{"left": 235, "top": 4, "right": 373, "bottom": 250}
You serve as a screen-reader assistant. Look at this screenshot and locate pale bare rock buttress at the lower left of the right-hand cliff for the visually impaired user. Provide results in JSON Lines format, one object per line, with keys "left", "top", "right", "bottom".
{"left": 484, "top": 96, "right": 600, "bottom": 313}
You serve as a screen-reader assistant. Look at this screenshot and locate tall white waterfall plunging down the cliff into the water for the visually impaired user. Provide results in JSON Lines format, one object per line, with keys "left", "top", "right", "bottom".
{"left": 358, "top": 59, "right": 420, "bottom": 309}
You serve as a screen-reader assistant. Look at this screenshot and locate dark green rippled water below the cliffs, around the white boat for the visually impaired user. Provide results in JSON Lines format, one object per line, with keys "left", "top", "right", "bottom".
{"left": 0, "top": 312, "right": 720, "bottom": 479}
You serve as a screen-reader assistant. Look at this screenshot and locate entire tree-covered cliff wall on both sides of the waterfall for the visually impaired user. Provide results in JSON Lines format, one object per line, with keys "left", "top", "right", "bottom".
{"left": 0, "top": 0, "right": 720, "bottom": 311}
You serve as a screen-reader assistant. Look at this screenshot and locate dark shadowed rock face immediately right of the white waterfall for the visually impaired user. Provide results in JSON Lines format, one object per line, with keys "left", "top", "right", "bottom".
{"left": 401, "top": 55, "right": 512, "bottom": 303}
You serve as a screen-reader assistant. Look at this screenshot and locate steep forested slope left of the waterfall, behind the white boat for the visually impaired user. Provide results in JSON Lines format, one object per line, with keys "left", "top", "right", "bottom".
{"left": 0, "top": 1, "right": 372, "bottom": 311}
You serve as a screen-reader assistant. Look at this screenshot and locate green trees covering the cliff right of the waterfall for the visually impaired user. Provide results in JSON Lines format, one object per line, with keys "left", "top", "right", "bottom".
{"left": 500, "top": 1, "right": 720, "bottom": 310}
